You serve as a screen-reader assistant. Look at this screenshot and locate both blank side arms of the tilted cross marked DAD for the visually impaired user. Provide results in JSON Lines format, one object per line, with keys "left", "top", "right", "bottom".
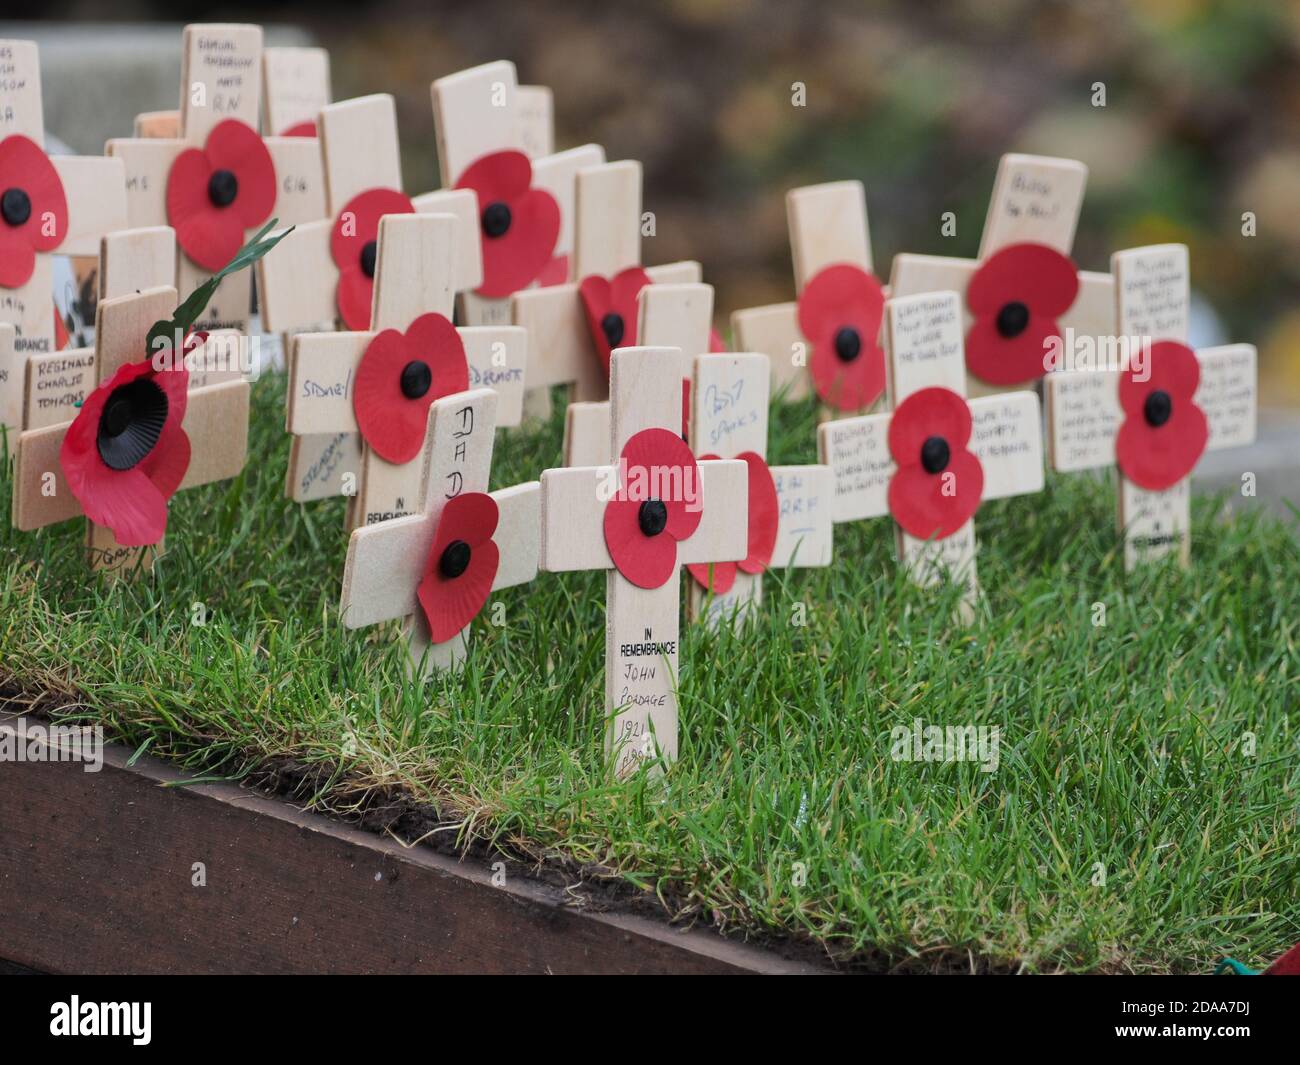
{"left": 339, "top": 481, "right": 541, "bottom": 628}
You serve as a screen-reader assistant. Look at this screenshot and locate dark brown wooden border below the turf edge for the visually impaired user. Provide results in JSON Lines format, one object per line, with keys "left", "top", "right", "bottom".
{"left": 0, "top": 718, "right": 824, "bottom": 973}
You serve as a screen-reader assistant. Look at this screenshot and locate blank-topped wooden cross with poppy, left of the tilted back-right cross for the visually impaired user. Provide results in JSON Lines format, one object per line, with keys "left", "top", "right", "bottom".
{"left": 732, "top": 181, "right": 885, "bottom": 417}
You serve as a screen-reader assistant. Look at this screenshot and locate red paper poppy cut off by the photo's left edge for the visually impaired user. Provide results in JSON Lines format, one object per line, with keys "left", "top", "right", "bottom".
{"left": 0, "top": 133, "right": 68, "bottom": 289}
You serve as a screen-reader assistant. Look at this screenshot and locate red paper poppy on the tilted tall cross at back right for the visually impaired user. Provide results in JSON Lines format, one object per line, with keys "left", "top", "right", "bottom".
{"left": 966, "top": 243, "right": 1079, "bottom": 385}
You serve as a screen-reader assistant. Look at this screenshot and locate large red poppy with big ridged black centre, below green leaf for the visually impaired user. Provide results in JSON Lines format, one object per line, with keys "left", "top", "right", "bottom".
{"left": 59, "top": 359, "right": 190, "bottom": 547}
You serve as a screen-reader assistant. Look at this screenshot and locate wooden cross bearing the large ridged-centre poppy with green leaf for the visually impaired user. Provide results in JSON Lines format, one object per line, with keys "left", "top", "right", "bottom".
{"left": 13, "top": 286, "right": 250, "bottom": 575}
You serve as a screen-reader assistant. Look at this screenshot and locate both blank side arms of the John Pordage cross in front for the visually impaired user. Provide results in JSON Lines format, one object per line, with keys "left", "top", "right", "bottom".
{"left": 540, "top": 459, "right": 749, "bottom": 573}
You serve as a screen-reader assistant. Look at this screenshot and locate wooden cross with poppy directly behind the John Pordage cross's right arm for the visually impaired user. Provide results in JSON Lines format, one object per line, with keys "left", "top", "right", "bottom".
{"left": 689, "top": 352, "right": 835, "bottom": 627}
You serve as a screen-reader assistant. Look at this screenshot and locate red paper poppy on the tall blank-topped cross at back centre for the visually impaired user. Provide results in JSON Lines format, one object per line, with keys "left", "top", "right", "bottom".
{"left": 456, "top": 151, "right": 567, "bottom": 299}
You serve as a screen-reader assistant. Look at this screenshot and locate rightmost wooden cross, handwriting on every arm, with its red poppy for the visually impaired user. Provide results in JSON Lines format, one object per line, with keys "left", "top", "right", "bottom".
{"left": 1045, "top": 244, "right": 1258, "bottom": 570}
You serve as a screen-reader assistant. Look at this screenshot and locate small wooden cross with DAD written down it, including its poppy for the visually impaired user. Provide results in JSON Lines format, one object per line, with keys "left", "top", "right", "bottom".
{"left": 339, "top": 389, "right": 541, "bottom": 675}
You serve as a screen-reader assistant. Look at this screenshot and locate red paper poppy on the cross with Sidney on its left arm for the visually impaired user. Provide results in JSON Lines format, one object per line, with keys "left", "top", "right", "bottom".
{"left": 352, "top": 313, "right": 469, "bottom": 463}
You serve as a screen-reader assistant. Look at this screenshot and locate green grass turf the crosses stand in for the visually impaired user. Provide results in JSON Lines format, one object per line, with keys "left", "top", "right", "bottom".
{"left": 0, "top": 377, "right": 1300, "bottom": 971}
